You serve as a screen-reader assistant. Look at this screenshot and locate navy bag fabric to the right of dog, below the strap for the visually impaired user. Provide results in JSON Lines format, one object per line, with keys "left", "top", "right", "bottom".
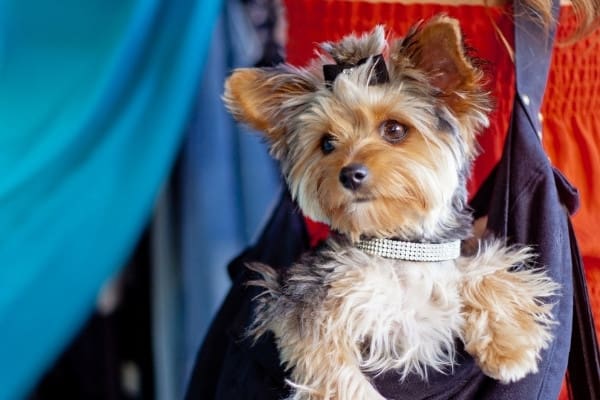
{"left": 468, "top": 95, "right": 577, "bottom": 399}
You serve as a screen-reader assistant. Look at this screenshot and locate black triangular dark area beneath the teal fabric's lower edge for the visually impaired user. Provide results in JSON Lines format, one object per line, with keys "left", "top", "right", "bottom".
{"left": 27, "top": 230, "right": 155, "bottom": 400}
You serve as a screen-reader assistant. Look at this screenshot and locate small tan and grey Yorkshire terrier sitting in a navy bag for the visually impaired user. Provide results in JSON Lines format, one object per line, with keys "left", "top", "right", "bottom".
{"left": 224, "top": 16, "right": 559, "bottom": 400}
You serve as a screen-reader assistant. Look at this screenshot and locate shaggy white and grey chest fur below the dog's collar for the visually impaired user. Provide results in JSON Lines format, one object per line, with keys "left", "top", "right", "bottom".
{"left": 251, "top": 240, "right": 463, "bottom": 376}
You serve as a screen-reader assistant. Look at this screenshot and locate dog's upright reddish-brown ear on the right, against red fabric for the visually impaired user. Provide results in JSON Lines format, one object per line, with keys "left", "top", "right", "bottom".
{"left": 391, "top": 16, "right": 489, "bottom": 116}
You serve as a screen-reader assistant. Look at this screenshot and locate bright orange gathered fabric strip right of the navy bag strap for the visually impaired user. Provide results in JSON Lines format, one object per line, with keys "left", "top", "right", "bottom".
{"left": 542, "top": 7, "right": 600, "bottom": 342}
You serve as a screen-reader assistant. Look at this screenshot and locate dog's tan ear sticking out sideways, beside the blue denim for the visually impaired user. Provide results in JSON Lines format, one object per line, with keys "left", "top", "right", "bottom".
{"left": 223, "top": 66, "right": 316, "bottom": 159}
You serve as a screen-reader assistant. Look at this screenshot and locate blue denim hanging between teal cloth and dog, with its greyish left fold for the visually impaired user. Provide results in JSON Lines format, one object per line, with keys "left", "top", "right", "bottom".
{"left": 153, "top": 0, "right": 280, "bottom": 399}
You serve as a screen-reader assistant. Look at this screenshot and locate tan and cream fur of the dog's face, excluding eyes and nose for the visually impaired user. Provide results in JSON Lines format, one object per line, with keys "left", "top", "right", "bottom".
{"left": 288, "top": 78, "right": 462, "bottom": 239}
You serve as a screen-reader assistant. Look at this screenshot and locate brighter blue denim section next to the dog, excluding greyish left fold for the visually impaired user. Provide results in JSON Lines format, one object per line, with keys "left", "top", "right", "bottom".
{"left": 176, "top": 0, "right": 280, "bottom": 384}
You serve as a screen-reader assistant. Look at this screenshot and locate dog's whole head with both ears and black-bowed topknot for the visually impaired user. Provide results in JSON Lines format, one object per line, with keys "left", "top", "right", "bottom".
{"left": 224, "top": 17, "right": 489, "bottom": 240}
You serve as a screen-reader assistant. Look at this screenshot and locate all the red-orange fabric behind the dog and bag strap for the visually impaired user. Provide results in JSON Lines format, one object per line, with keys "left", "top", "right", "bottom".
{"left": 285, "top": 0, "right": 600, "bottom": 399}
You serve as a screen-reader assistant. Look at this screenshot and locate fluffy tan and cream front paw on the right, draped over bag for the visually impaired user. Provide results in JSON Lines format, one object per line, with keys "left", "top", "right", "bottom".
{"left": 462, "top": 242, "right": 559, "bottom": 383}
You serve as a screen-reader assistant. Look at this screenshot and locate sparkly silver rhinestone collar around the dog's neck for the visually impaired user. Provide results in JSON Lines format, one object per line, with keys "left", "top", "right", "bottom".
{"left": 356, "top": 239, "right": 460, "bottom": 261}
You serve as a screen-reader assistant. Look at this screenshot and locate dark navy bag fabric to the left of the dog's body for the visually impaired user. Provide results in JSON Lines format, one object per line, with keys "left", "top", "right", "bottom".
{"left": 185, "top": 192, "right": 309, "bottom": 400}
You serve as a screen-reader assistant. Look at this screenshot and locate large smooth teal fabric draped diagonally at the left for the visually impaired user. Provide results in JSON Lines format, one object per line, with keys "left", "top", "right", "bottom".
{"left": 0, "top": 0, "right": 220, "bottom": 399}
